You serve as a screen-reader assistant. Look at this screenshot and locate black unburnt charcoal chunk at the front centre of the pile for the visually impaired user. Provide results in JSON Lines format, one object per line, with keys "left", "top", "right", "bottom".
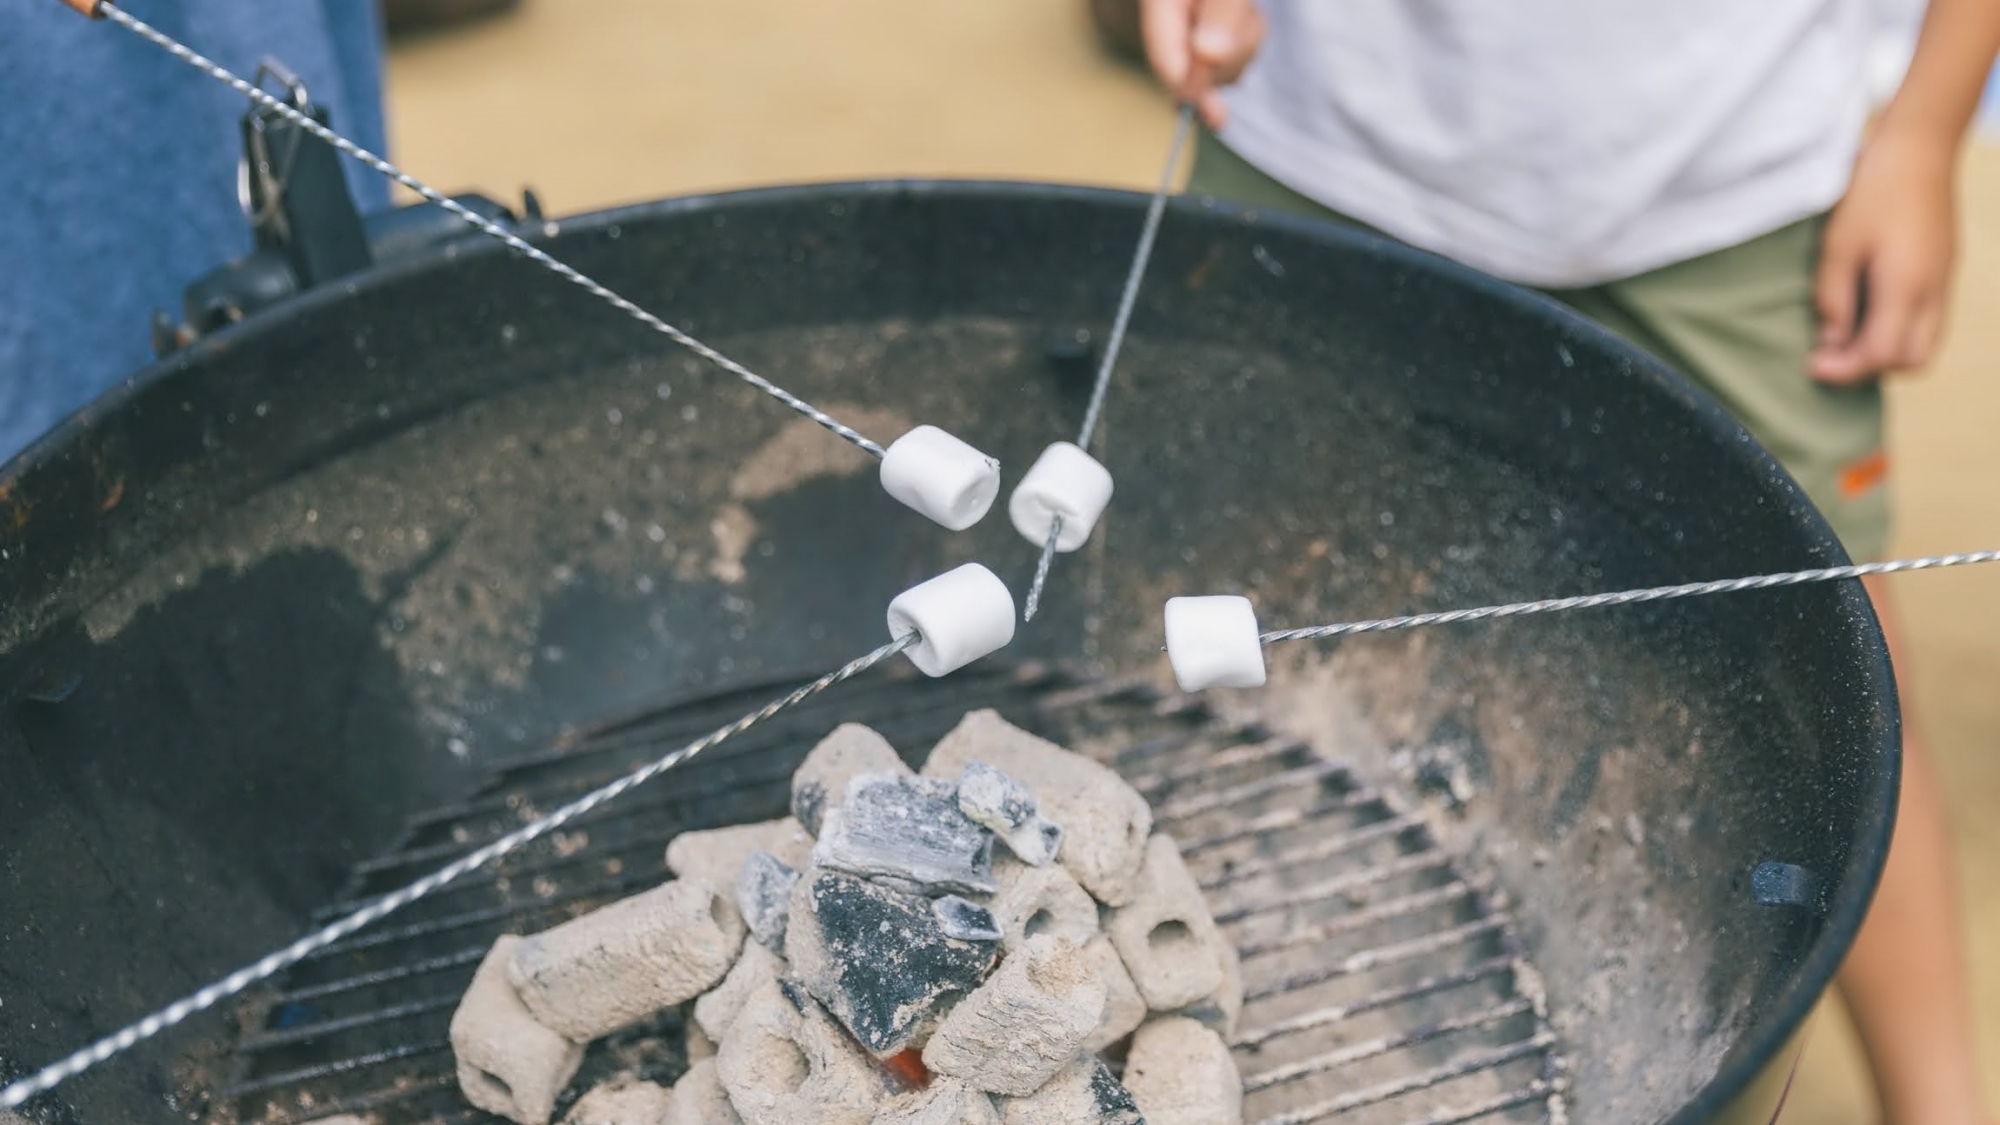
{"left": 784, "top": 871, "right": 1000, "bottom": 1057}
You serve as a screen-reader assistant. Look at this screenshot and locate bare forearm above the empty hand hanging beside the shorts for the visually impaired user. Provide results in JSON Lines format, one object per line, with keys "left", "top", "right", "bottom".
{"left": 1882, "top": 0, "right": 2000, "bottom": 152}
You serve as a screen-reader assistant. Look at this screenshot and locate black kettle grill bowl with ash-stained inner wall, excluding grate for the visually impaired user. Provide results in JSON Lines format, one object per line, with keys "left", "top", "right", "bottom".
{"left": 0, "top": 184, "right": 1898, "bottom": 1125}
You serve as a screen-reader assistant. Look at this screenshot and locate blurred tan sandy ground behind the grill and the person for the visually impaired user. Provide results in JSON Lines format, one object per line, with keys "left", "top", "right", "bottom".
{"left": 390, "top": 0, "right": 2000, "bottom": 1125}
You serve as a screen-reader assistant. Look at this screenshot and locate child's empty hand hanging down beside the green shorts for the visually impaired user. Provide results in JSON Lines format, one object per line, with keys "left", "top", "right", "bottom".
{"left": 1808, "top": 120, "right": 1956, "bottom": 384}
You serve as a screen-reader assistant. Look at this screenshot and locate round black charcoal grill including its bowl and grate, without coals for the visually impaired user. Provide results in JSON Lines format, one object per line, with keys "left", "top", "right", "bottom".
{"left": 0, "top": 184, "right": 1896, "bottom": 1125}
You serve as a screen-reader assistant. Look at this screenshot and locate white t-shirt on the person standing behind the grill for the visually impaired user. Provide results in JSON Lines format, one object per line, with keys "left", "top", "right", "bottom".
{"left": 1222, "top": 0, "right": 1870, "bottom": 286}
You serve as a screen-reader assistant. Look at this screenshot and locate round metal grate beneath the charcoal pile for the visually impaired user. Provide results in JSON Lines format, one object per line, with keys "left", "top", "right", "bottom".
{"left": 208, "top": 665, "right": 1564, "bottom": 1125}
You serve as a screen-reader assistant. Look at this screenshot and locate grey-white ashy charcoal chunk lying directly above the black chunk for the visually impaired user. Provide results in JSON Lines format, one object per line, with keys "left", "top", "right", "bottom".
{"left": 812, "top": 773, "right": 994, "bottom": 895}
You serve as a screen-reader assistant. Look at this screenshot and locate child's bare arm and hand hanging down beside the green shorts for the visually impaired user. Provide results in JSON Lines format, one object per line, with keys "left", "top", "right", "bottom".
{"left": 1810, "top": 0, "right": 2000, "bottom": 382}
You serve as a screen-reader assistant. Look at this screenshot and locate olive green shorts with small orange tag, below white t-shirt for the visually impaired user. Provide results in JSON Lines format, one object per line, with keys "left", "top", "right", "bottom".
{"left": 1188, "top": 132, "right": 1888, "bottom": 560}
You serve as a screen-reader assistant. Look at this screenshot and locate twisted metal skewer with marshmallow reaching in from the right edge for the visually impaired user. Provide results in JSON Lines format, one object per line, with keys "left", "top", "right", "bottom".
{"left": 1166, "top": 550, "right": 2000, "bottom": 691}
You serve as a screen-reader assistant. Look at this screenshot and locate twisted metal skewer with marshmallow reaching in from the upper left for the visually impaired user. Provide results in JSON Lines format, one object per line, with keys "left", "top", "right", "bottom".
{"left": 62, "top": 0, "right": 1000, "bottom": 530}
